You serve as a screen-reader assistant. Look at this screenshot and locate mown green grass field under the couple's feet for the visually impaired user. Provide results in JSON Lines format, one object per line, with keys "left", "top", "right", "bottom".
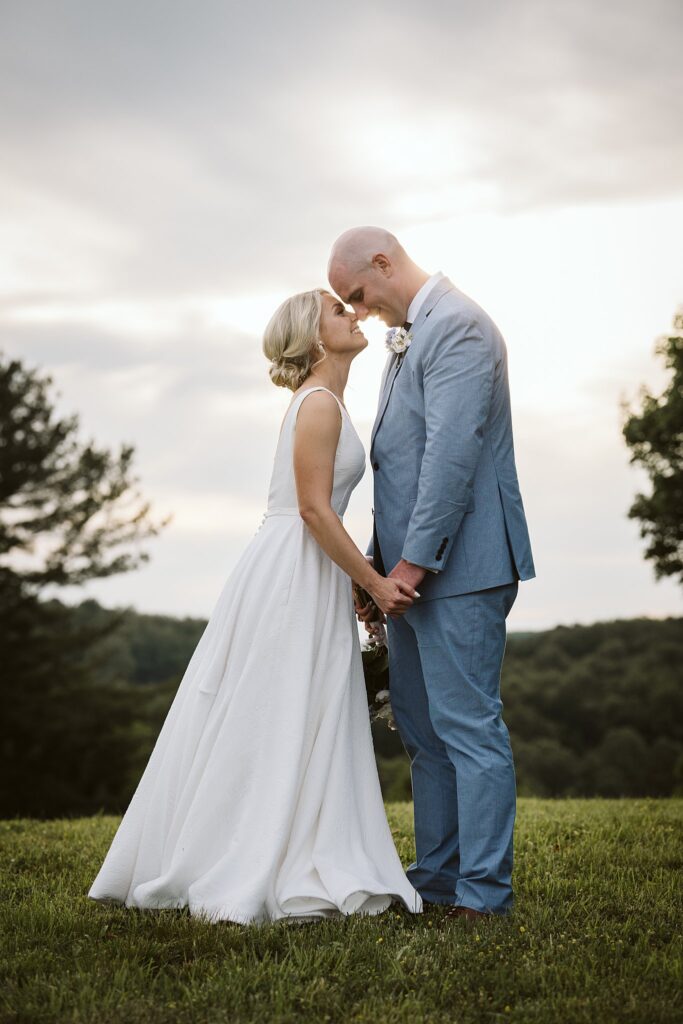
{"left": 0, "top": 799, "right": 683, "bottom": 1024}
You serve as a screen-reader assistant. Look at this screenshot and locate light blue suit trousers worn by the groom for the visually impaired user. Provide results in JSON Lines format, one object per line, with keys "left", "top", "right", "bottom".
{"left": 387, "top": 581, "right": 519, "bottom": 914}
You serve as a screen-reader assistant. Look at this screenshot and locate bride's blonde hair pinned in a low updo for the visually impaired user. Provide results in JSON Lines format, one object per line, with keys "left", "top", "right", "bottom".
{"left": 263, "top": 288, "right": 329, "bottom": 391}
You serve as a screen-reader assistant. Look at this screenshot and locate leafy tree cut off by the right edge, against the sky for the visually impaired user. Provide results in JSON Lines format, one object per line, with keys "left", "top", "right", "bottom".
{"left": 623, "top": 309, "right": 683, "bottom": 584}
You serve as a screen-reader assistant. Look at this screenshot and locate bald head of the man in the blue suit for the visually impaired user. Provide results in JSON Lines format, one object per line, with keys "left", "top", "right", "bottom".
{"left": 328, "top": 227, "right": 429, "bottom": 327}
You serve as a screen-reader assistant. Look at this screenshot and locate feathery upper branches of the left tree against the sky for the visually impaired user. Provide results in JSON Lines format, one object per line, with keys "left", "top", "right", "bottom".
{"left": 0, "top": 353, "right": 169, "bottom": 594}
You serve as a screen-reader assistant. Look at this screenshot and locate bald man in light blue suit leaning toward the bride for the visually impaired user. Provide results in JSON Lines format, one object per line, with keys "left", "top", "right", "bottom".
{"left": 328, "top": 227, "right": 536, "bottom": 920}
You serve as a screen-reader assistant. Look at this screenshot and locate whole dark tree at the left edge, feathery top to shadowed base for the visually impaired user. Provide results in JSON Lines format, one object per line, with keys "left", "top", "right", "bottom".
{"left": 0, "top": 352, "right": 168, "bottom": 816}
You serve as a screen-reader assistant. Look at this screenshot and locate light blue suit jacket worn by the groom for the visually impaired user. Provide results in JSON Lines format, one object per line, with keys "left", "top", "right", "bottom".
{"left": 368, "top": 278, "right": 536, "bottom": 600}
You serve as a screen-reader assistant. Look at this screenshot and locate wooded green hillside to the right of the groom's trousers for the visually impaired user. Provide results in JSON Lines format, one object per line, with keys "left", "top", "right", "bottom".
{"left": 502, "top": 618, "right": 683, "bottom": 797}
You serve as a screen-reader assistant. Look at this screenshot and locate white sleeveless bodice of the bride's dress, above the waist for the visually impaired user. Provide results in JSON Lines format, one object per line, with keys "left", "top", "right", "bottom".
{"left": 266, "top": 385, "right": 366, "bottom": 516}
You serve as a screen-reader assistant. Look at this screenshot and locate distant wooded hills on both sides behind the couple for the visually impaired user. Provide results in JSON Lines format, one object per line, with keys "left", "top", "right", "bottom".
{"left": 66, "top": 601, "right": 683, "bottom": 797}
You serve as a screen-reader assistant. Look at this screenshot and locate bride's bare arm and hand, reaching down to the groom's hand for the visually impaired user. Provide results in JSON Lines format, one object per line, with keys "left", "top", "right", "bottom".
{"left": 294, "top": 391, "right": 419, "bottom": 615}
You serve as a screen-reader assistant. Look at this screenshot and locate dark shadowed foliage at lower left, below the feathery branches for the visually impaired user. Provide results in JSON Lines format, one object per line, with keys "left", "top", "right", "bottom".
{"left": 0, "top": 585, "right": 143, "bottom": 816}
